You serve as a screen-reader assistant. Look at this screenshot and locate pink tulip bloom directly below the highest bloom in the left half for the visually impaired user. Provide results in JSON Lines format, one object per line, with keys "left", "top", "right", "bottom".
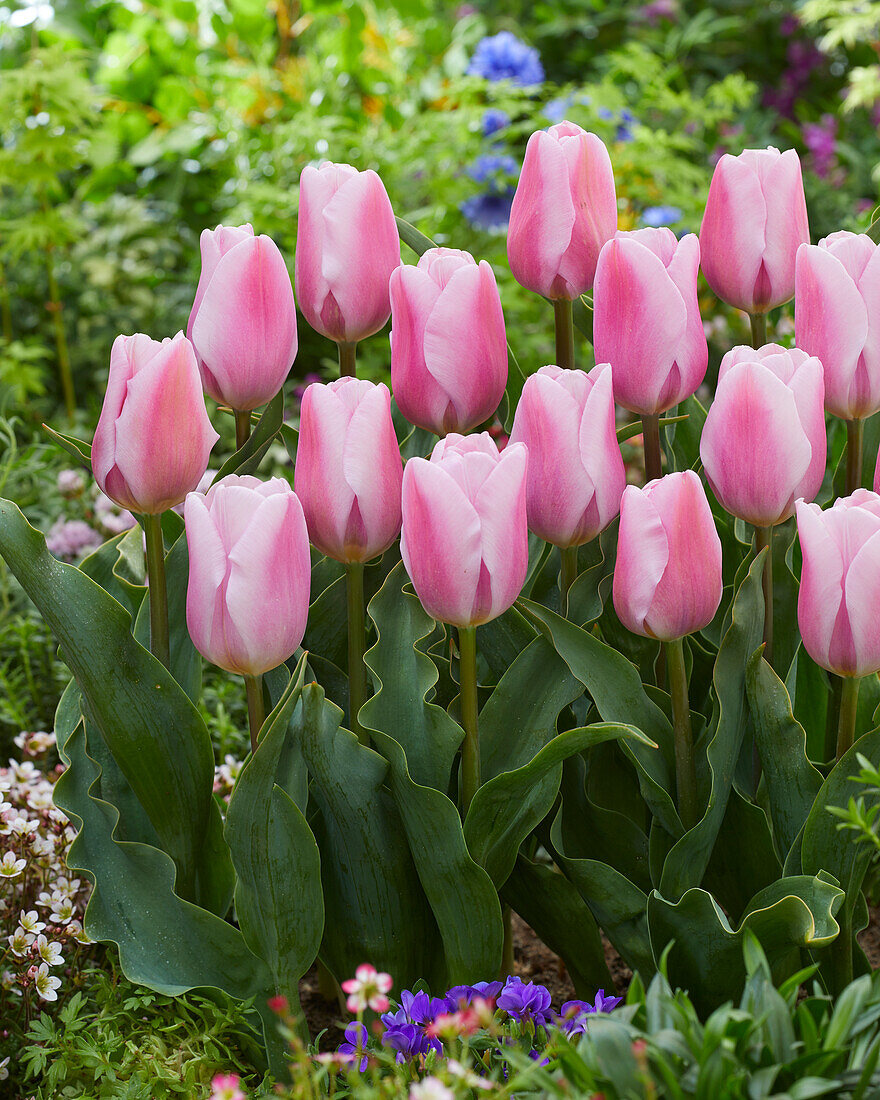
{"left": 294, "top": 378, "right": 404, "bottom": 562}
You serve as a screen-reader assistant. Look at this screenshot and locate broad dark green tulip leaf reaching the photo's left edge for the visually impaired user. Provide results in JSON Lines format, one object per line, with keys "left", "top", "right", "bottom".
{"left": 0, "top": 501, "right": 231, "bottom": 912}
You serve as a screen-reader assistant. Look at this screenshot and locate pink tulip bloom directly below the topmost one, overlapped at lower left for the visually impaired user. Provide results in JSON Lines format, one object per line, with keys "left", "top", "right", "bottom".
{"left": 510, "top": 363, "right": 626, "bottom": 548}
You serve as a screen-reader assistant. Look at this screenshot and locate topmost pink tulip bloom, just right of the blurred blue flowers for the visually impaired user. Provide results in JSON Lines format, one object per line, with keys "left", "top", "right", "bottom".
{"left": 507, "top": 122, "right": 617, "bottom": 299}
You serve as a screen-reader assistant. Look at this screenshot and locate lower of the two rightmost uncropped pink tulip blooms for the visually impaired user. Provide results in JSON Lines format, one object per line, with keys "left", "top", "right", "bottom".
{"left": 700, "top": 344, "right": 826, "bottom": 527}
